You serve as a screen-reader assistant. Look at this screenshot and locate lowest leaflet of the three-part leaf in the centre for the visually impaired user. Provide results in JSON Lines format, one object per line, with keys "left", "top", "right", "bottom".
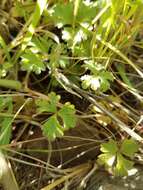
{"left": 42, "top": 115, "right": 63, "bottom": 140}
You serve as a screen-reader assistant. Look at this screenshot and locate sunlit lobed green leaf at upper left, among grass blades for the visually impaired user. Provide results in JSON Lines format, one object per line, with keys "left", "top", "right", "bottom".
{"left": 21, "top": 50, "right": 45, "bottom": 74}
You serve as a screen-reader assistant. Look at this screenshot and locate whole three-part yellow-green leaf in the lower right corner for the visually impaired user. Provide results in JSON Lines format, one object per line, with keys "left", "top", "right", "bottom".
{"left": 98, "top": 139, "right": 139, "bottom": 176}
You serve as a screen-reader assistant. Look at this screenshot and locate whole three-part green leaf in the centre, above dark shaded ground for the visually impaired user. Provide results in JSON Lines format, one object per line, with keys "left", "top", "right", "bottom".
{"left": 36, "top": 92, "right": 76, "bottom": 140}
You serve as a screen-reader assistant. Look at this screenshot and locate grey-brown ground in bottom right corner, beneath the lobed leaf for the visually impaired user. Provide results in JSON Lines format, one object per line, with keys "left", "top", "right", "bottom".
{"left": 86, "top": 166, "right": 143, "bottom": 190}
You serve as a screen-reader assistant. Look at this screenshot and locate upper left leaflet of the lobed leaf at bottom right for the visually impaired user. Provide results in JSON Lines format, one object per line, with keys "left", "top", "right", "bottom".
{"left": 100, "top": 139, "right": 118, "bottom": 155}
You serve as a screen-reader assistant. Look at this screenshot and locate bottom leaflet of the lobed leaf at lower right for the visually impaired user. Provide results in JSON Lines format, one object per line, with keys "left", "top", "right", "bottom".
{"left": 114, "top": 153, "right": 133, "bottom": 176}
